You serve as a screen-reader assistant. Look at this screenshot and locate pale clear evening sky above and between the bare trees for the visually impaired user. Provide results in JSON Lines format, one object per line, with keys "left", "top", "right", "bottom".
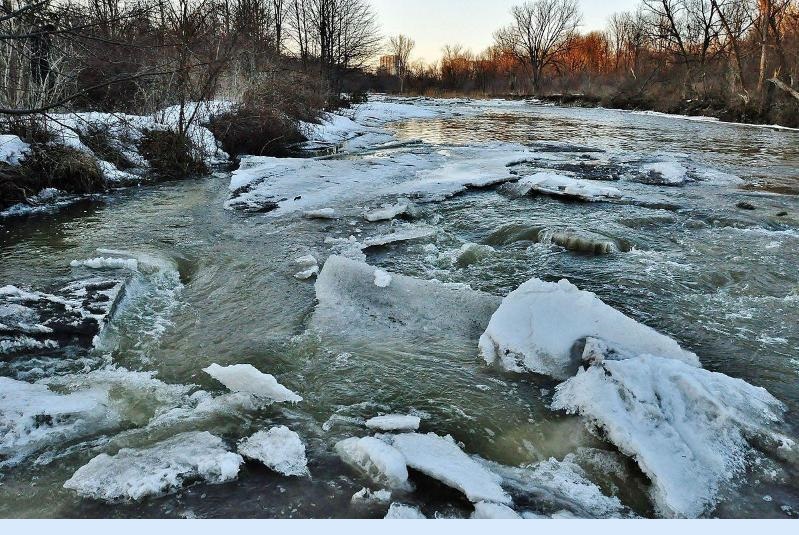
{"left": 369, "top": 0, "right": 640, "bottom": 62}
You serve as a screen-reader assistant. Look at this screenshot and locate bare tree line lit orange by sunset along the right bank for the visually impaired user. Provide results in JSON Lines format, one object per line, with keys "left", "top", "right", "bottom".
{"left": 379, "top": 0, "right": 799, "bottom": 124}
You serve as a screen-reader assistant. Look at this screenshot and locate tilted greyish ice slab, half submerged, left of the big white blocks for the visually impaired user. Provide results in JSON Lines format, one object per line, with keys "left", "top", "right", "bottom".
{"left": 311, "top": 256, "right": 500, "bottom": 342}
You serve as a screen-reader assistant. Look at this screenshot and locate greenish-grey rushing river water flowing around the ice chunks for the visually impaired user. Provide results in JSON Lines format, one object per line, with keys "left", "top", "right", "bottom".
{"left": 0, "top": 102, "right": 799, "bottom": 518}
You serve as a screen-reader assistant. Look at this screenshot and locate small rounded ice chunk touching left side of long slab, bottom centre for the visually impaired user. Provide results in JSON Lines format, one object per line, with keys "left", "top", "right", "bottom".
{"left": 336, "top": 437, "right": 410, "bottom": 489}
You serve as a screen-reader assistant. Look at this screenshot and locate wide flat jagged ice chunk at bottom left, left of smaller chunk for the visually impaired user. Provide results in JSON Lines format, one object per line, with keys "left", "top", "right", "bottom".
{"left": 64, "top": 432, "right": 243, "bottom": 502}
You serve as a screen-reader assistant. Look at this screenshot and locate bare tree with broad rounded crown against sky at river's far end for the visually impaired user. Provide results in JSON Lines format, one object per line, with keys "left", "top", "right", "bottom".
{"left": 495, "top": 0, "right": 582, "bottom": 91}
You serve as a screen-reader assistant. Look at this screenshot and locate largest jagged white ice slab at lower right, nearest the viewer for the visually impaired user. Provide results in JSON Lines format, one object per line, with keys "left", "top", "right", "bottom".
{"left": 552, "top": 356, "right": 785, "bottom": 517}
